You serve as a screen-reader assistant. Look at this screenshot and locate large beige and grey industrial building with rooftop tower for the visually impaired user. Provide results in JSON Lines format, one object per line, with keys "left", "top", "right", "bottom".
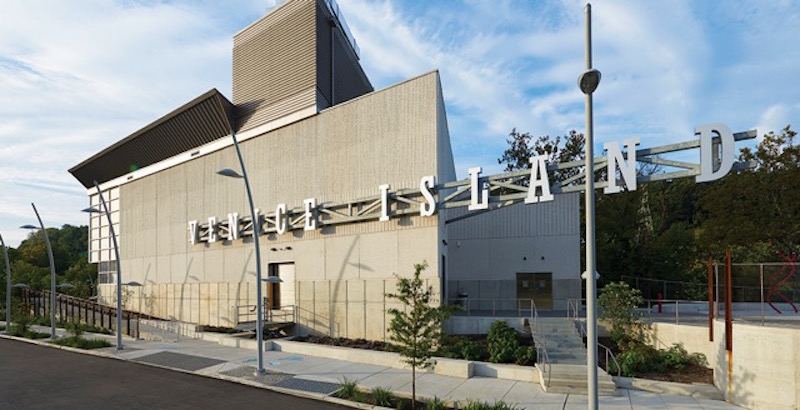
{"left": 70, "top": 0, "right": 581, "bottom": 340}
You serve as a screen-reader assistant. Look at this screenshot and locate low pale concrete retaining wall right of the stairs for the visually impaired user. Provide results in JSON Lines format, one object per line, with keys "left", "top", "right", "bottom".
{"left": 653, "top": 320, "right": 800, "bottom": 409}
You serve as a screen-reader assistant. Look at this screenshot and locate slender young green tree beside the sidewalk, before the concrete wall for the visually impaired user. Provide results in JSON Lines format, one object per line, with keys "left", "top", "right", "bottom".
{"left": 386, "top": 262, "right": 453, "bottom": 410}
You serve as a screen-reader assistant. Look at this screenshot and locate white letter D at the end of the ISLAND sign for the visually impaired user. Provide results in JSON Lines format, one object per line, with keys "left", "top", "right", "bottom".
{"left": 694, "top": 124, "right": 736, "bottom": 182}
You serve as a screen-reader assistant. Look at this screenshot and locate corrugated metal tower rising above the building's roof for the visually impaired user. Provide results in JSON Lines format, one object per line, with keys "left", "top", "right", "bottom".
{"left": 233, "top": 0, "right": 373, "bottom": 131}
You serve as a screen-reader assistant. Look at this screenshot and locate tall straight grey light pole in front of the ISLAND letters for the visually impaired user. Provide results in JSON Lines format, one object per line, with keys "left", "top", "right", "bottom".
{"left": 578, "top": 3, "right": 614, "bottom": 409}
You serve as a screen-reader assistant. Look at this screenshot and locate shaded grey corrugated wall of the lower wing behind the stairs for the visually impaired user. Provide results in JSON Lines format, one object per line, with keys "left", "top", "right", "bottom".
{"left": 447, "top": 193, "right": 581, "bottom": 310}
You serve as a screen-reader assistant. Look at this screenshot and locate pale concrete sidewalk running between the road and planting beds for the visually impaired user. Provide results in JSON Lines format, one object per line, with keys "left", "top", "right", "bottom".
{"left": 4, "top": 326, "right": 739, "bottom": 410}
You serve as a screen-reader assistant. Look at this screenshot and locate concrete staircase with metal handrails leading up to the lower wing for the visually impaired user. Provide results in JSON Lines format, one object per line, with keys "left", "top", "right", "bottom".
{"left": 532, "top": 318, "right": 619, "bottom": 396}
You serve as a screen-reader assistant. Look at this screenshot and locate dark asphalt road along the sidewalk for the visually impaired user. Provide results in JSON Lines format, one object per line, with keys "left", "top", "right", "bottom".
{"left": 0, "top": 339, "right": 346, "bottom": 410}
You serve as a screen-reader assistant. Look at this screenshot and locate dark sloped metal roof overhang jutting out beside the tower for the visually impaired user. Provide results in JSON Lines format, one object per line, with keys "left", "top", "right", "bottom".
{"left": 69, "top": 88, "right": 234, "bottom": 188}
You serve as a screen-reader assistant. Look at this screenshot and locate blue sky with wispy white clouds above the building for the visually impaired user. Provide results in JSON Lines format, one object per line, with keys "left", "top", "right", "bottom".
{"left": 0, "top": 0, "right": 800, "bottom": 246}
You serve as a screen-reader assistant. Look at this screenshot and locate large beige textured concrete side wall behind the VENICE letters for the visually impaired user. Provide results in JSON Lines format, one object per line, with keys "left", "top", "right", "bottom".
{"left": 102, "top": 72, "right": 455, "bottom": 339}
